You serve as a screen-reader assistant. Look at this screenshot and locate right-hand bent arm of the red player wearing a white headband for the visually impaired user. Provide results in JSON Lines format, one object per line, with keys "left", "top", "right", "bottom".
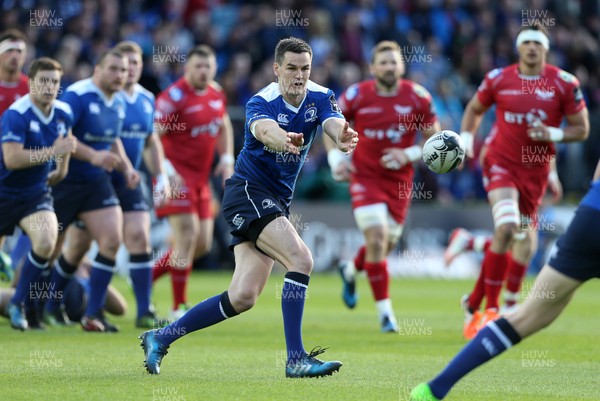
{"left": 527, "top": 108, "right": 590, "bottom": 142}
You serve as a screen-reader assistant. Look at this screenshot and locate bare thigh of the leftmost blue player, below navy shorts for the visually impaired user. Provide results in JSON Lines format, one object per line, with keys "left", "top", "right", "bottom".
{"left": 19, "top": 210, "right": 58, "bottom": 257}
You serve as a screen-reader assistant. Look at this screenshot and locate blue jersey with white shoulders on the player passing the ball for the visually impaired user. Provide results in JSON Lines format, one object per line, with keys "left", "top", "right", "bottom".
{"left": 233, "top": 81, "right": 344, "bottom": 206}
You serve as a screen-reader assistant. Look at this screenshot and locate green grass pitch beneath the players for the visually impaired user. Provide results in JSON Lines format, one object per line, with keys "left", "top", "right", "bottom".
{"left": 0, "top": 271, "right": 600, "bottom": 401}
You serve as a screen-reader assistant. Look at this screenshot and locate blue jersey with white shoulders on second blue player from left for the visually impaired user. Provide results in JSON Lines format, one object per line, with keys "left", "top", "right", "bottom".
{"left": 62, "top": 78, "right": 125, "bottom": 181}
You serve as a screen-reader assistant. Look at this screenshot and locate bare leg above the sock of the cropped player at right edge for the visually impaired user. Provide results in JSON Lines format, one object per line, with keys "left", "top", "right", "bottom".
{"left": 507, "top": 265, "right": 582, "bottom": 338}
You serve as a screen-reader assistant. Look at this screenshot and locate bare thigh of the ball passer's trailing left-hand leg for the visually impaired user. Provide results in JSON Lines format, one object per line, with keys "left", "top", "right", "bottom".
{"left": 228, "top": 241, "right": 274, "bottom": 306}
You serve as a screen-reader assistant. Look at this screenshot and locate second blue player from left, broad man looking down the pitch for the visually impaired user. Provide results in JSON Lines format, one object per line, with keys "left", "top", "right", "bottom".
{"left": 44, "top": 49, "right": 139, "bottom": 332}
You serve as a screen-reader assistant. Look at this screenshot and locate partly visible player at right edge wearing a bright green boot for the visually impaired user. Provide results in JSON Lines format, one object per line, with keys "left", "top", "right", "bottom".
{"left": 410, "top": 158, "right": 600, "bottom": 401}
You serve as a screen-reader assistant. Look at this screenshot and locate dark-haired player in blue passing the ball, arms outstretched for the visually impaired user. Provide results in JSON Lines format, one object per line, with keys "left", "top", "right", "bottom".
{"left": 140, "top": 38, "right": 358, "bottom": 377}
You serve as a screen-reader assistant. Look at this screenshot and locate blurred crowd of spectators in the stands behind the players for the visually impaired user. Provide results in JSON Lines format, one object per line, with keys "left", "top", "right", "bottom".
{"left": 0, "top": 0, "right": 600, "bottom": 202}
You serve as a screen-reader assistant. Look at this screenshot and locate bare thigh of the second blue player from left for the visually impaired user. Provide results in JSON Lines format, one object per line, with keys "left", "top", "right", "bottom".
{"left": 79, "top": 206, "right": 123, "bottom": 248}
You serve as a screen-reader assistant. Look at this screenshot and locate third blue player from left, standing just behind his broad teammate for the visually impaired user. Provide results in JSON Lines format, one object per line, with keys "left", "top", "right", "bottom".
{"left": 63, "top": 41, "right": 169, "bottom": 328}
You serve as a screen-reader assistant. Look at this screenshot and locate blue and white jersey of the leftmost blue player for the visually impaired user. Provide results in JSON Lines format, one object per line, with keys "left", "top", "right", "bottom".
{"left": 0, "top": 95, "right": 73, "bottom": 199}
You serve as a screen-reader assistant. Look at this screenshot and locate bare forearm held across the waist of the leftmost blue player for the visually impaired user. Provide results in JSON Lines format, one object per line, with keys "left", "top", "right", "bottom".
{"left": 2, "top": 131, "right": 77, "bottom": 170}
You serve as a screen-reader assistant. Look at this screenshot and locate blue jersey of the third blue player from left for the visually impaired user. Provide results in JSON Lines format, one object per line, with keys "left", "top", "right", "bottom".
{"left": 112, "top": 84, "right": 155, "bottom": 181}
